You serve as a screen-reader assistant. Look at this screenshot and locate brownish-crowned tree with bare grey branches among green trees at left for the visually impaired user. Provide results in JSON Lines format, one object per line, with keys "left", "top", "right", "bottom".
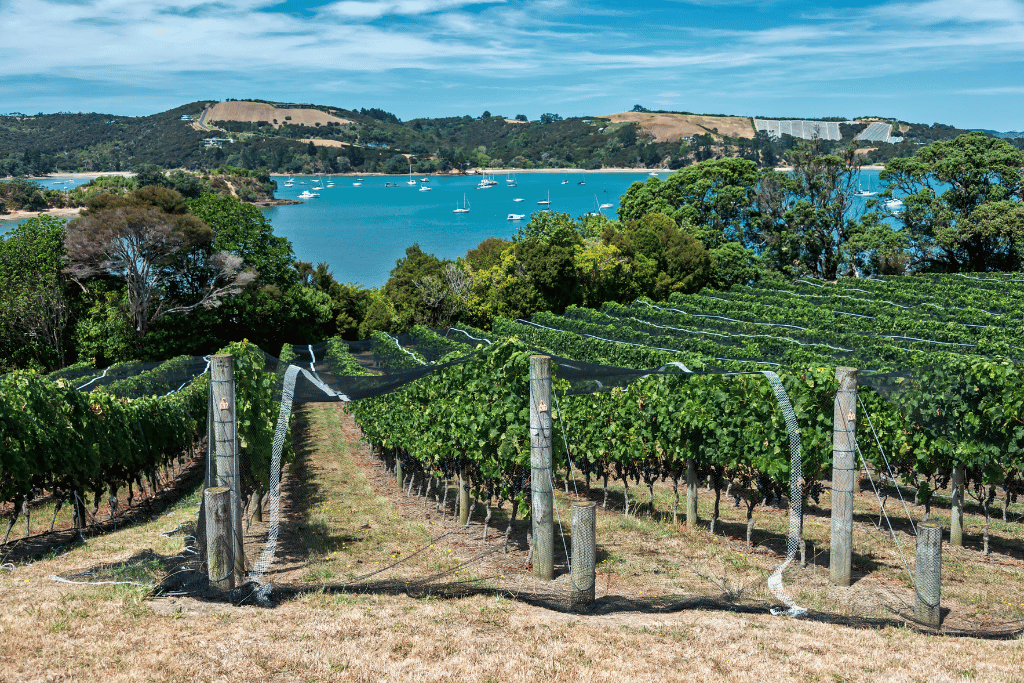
{"left": 65, "top": 190, "right": 253, "bottom": 338}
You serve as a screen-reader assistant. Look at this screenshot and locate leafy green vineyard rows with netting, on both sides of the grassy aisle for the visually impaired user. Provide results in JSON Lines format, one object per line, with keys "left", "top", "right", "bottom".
{"left": 0, "top": 275, "right": 1024, "bottom": 633}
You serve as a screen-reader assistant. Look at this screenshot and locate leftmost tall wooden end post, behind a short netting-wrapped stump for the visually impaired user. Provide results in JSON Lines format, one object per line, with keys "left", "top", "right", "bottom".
{"left": 208, "top": 353, "right": 246, "bottom": 584}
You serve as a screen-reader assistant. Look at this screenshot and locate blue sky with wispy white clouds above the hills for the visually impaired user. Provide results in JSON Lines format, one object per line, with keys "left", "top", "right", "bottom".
{"left": 0, "top": 0, "right": 1024, "bottom": 131}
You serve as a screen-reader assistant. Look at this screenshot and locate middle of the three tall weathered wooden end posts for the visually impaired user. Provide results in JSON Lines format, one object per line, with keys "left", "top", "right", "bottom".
{"left": 532, "top": 355, "right": 555, "bottom": 581}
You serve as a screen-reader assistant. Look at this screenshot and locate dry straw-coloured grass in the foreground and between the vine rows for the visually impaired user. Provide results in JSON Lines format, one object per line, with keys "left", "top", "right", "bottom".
{"left": 0, "top": 405, "right": 1024, "bottom": 683}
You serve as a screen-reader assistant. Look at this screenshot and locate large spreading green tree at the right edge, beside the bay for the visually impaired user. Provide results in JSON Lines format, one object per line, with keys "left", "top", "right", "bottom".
{"left": 879, "top": 132, "right": 1024, "bottom": 271}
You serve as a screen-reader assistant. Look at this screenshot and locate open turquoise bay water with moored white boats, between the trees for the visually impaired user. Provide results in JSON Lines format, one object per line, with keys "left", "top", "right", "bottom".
{"left": 265, "top": 171, "right": 651, "bottom": 287}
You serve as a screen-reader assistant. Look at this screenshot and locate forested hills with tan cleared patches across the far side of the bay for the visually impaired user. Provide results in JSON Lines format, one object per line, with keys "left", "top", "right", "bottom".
{"left": 0, "top": 100, "right": 1024, "bottom": 176}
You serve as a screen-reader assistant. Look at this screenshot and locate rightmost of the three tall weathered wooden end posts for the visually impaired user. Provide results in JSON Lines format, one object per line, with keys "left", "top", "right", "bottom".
{"left": 828, "top": 368, "right": 857, "bottom": 586}
